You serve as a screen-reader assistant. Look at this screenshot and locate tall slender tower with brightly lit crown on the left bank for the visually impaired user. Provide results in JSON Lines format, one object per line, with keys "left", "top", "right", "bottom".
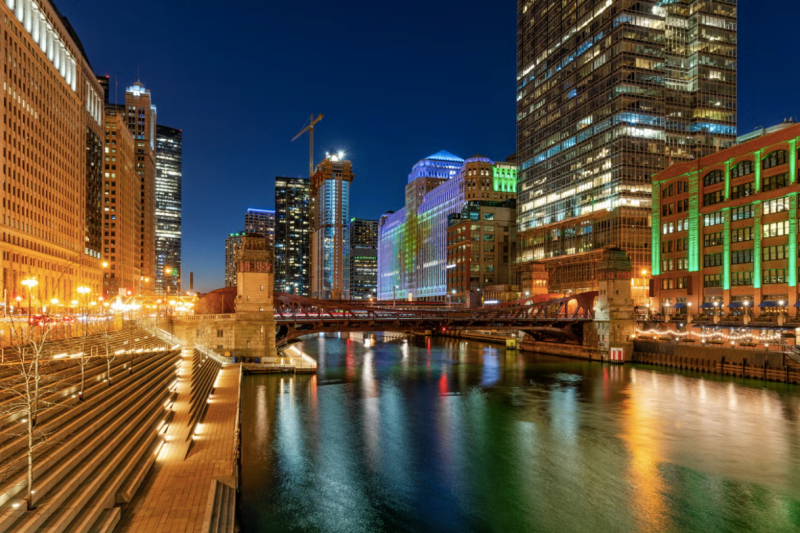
{"left": 125, "top": 81, "right": 156, "bottom": 290}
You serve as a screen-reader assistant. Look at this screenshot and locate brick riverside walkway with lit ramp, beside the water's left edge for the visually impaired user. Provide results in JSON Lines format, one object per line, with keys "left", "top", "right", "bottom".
{"left": 115, "top": 350, "right": 240, "bottom": 533}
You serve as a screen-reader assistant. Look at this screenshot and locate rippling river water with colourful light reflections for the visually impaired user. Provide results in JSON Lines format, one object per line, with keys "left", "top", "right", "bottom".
{"left": 241, "top": 337, "right": 800, "bottom": 532}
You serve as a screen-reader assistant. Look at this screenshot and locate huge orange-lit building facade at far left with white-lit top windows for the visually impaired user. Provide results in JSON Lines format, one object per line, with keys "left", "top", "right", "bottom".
{"left": 0, "top": 0, "right": 104, "bottom": 308}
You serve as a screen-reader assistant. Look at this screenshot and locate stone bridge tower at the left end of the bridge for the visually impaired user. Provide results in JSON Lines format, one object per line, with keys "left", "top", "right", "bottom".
{"left": 233, "top": 233, "right": 276, "bottom": 357}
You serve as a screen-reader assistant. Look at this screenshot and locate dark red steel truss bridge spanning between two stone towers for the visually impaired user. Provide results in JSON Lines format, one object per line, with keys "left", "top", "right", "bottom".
{"left": 273, "top": 291, "right": 598, "bottom": 349}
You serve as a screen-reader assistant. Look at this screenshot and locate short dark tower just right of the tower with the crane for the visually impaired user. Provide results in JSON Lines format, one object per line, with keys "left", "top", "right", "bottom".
{"left": 350, "top": 218, "right": 378, "bottom": 300}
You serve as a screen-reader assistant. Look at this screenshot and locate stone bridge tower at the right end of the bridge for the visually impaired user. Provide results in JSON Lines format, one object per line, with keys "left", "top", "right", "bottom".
{"left": 586, "top": 248, "right": 636, "bottom": 360}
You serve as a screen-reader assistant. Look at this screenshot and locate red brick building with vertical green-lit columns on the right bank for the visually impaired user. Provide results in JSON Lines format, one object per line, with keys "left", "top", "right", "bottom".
{"left": 650, "top": 120, "right": 800, "bottom": 314}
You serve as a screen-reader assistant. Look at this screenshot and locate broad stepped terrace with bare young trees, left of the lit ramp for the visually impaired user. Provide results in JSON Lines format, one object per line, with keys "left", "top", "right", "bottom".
{"left": 0, "top": 338, "right": 180, "bottom": 531}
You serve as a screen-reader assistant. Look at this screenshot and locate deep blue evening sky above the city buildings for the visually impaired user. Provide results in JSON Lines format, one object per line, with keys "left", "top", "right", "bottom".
{"left": 57, "top": 0, "right": 800, "bottom": 291}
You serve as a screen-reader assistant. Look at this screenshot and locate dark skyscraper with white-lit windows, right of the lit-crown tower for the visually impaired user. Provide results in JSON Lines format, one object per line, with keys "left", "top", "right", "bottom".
{"left": 156, "top": 124, "right": 183, "bottom": 294}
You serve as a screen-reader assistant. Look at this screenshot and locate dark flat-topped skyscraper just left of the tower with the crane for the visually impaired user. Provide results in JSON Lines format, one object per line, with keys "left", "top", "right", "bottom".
{"left": 275, "top": 177, "right": 311, "bottom": 296}
